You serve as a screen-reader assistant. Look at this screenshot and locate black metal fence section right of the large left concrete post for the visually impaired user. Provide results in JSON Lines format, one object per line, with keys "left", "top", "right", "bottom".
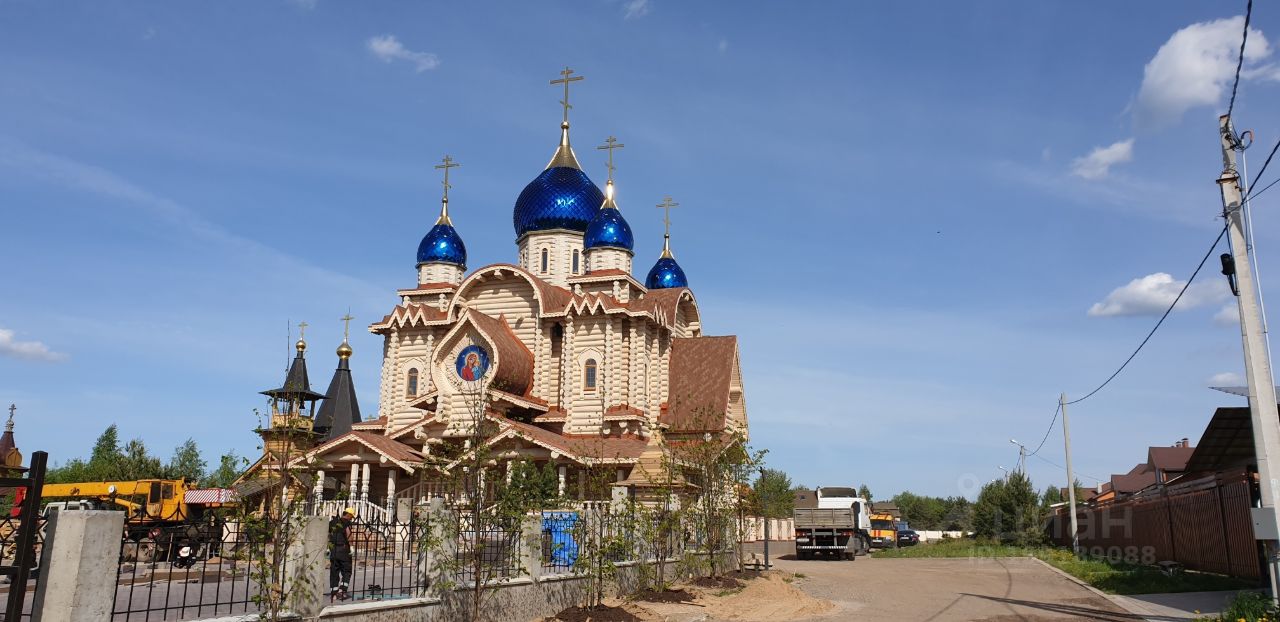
{"left": 111, "top": 520, "right": 262, "bottom": 622}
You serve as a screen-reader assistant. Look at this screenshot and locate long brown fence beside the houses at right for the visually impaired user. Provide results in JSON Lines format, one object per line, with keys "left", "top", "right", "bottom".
{"left": 1050, "top": 468, "right": 1262, "bottom": 578}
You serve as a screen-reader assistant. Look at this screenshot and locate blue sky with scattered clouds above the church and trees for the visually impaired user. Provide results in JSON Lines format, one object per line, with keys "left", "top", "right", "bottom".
{"left": 0, "top": 0, "right": 1280, "bottom": 497}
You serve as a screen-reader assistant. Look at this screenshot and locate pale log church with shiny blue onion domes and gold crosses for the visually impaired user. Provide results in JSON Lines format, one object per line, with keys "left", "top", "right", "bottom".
{"left": 248, "top": 68, "right": 748, "bottom": 516}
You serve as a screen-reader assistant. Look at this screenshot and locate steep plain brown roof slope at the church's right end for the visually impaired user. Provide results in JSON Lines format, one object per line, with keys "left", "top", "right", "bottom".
{"left": 659, "top": 337, "right": 737, "bottom": 433}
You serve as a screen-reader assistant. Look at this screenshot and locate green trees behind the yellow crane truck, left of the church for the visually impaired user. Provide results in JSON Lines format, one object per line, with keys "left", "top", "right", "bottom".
{"left": 45, "top": 424, "right": 246, "bottom": 488}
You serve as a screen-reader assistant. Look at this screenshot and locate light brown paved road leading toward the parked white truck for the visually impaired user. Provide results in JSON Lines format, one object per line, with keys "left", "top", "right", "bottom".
{"left": 754, "top": 543, "right": 1143, "bottom": 622}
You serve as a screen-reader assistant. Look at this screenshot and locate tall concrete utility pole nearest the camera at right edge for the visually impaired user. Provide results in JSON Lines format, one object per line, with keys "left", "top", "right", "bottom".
{"left": 1217, "top": 115, "right": 1280, "bottom": 600}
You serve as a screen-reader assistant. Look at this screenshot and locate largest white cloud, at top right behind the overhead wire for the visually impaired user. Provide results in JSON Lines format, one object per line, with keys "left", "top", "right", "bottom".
{"left": 1137, "top": 15, "right": 1280, "bottom": 125}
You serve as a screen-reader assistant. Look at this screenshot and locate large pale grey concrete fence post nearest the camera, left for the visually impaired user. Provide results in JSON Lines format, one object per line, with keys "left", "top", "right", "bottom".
{"left": 31, "top": 509, "right": 124, "bottom": 622}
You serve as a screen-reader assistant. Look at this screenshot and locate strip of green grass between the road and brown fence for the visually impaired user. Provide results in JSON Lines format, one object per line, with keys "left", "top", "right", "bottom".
{"left": 872, "top": 540, "right": 1257, "bottom": 594}
